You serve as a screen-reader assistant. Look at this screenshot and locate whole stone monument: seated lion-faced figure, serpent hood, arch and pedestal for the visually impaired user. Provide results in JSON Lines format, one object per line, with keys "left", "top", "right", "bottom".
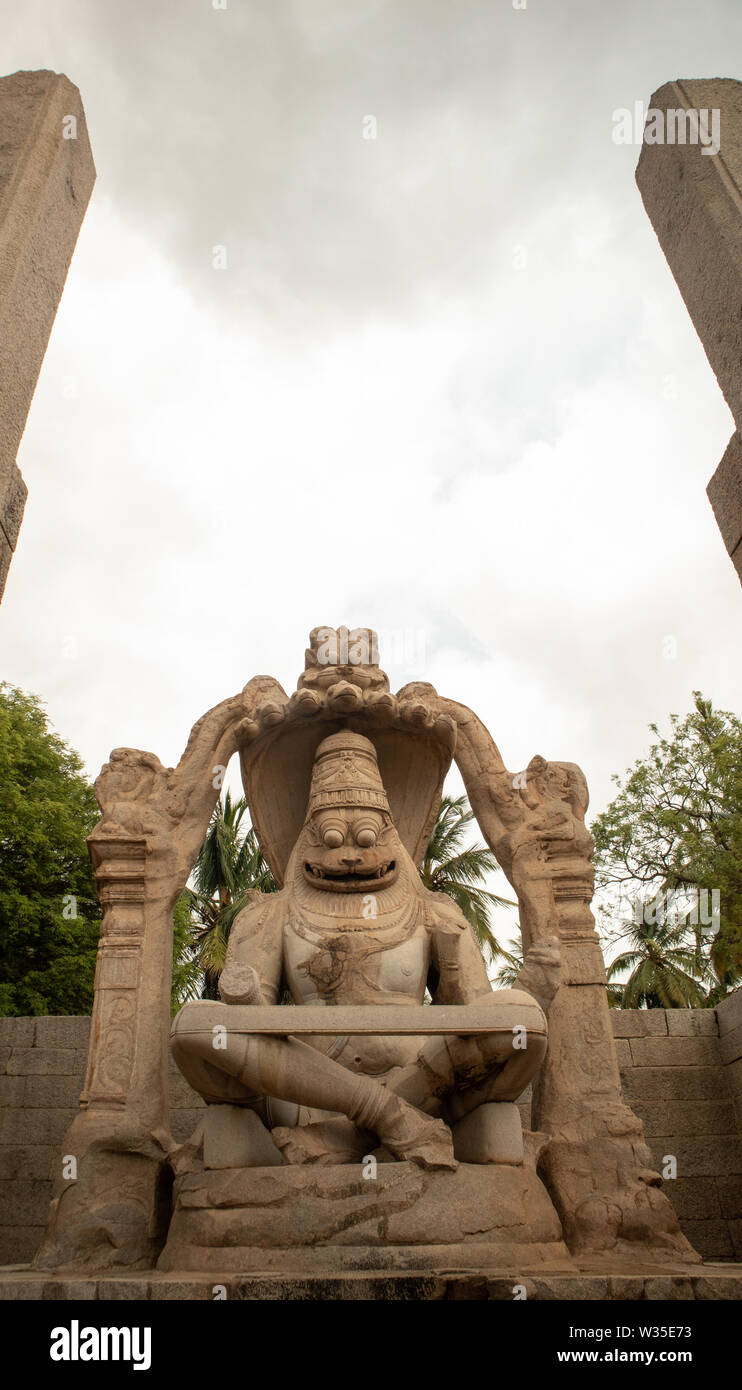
{"left": 36, "top": 628, "right": 699, "bottom": 1272}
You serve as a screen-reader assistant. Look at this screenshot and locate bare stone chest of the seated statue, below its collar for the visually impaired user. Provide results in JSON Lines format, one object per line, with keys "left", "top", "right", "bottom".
{"left": 283, "top": 919, "right": 429, "bottom": 1005}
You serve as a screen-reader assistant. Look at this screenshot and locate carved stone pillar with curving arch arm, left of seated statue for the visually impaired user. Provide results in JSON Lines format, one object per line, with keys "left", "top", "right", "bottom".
{"left": 36, "top": 695, "right": 253, "bottom": 1269}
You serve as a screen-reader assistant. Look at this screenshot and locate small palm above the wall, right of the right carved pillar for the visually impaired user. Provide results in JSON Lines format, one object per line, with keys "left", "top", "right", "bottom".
{"left": 607, "top": 920, "right": 709, "bottom": 1009}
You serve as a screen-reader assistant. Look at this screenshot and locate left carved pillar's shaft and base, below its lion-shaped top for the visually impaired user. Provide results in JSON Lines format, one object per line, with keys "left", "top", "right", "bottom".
{"left": 35, "top": 833, "right": 172, "bottom": 1269}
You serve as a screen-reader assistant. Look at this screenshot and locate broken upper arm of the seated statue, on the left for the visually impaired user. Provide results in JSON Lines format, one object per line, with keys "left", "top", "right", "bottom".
{"left": 220, "top": 892, "right": 283, "bottom": 1004}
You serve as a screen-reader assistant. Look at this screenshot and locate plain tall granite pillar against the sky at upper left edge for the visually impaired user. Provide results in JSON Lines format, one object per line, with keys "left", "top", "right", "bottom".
{"left": 0, "top": 72, "right": 96, "bottom": 598}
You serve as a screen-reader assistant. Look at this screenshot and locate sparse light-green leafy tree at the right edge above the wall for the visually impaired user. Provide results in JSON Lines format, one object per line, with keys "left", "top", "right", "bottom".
{"left": 592, "top": 691, "right": 742, "bottom": 1008}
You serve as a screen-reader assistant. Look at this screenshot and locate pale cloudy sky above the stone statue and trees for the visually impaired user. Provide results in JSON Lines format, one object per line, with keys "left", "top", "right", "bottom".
{"left": 0, "top": 0, "right": 742, "bottom": 928}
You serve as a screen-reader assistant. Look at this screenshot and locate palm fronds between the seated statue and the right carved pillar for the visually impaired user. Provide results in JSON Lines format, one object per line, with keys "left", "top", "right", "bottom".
{"left": 420, "top": 796, "right": 517, "bottom": 959}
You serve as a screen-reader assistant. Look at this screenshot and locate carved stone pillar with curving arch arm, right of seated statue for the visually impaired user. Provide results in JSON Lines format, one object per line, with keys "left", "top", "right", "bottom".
{"left": 438, "top": 699, "right": 700, "bottom": 1264}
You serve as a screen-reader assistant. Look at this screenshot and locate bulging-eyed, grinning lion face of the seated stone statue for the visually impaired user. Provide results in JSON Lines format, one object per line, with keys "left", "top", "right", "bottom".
{"left": 304, "top": 806, "right": 400, "bottom": 892}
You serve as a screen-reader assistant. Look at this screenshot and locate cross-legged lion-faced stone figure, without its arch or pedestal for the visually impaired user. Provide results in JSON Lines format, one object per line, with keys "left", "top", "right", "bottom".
{"left": 172, "top": 730, "right": 559, "bottom": 1169}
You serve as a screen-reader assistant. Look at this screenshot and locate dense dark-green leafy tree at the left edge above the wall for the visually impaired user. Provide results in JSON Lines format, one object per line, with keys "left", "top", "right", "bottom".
{"left": 0, "top": 682, "right": 100, "bottom": 1017}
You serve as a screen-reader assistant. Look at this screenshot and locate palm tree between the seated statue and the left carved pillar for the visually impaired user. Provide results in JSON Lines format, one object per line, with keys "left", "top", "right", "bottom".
{"left": 185, "top": 792, "right": 278, "bottom": 999}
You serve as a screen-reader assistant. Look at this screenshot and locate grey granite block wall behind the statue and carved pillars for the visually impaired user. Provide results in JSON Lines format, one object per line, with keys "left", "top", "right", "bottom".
{"left": 0, "top": 990, "right": 742, "bottom": 1265}
